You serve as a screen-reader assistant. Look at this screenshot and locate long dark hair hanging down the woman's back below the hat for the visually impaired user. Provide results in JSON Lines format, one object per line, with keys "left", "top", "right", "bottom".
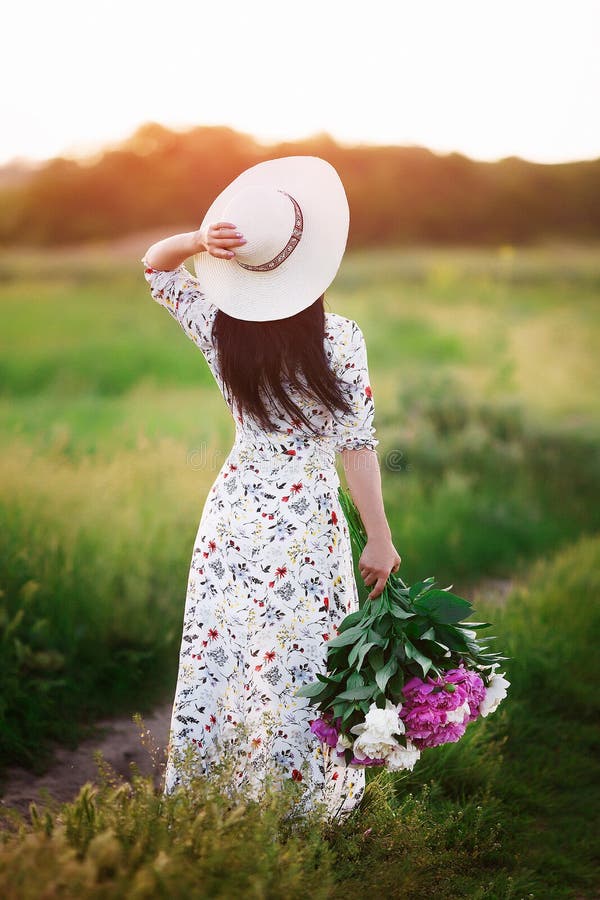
{"left": 212, "top": 294, "right": 352, "bottom": 434}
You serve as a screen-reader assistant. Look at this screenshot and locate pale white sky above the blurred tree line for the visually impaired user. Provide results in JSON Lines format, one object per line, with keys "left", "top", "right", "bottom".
{"left": 0, "top": 0, "right": 600, "bottom": 164}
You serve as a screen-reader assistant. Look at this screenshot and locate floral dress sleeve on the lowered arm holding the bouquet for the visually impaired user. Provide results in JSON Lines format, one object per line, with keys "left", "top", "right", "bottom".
{"left": 335, "top": 319, "right": 379, "bottom": 453}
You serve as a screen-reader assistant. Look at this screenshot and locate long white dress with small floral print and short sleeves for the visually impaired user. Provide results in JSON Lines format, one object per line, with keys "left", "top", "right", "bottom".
{"left": 142, "top": 257, "right": 378, "bottom": 818}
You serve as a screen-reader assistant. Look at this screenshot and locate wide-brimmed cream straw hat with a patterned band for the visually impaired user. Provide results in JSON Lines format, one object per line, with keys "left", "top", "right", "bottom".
{"left": 194, "top": 156, "right": 350, "bottom": 322}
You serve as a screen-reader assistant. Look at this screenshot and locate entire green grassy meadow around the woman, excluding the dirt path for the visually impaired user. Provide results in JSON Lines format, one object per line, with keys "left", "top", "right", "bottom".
{"left": 0, "top": 244, "right": 600, "bottom": 898}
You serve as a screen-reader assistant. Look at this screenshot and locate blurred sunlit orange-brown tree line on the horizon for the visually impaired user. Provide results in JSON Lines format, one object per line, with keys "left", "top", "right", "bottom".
{"left": 0, "top": 122, "right": 600, "bottom": 246}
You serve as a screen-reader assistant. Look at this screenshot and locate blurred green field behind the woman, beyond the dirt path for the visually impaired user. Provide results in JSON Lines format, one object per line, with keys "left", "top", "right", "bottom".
{"left": 0, "top": 247, "right": 600, "bottom": 769}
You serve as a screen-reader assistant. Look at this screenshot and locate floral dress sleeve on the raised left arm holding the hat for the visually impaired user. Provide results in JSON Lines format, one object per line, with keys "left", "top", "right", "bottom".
{"left": 141, "top": 256, "right": 217, "bottom": 353}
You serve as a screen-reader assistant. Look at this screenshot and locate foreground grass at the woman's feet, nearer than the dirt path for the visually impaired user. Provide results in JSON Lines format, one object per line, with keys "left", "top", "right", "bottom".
{"left": 0, "top": 538, "right": 600, "bottom": 900}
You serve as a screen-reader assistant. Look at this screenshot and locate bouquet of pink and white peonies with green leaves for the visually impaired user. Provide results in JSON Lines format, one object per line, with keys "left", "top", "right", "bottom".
{"left": 296, "top": 485, "right": 510, "bottom": 771}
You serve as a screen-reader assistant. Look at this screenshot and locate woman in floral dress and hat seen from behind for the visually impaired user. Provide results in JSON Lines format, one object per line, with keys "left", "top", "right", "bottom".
{"left": 142, "top": 156, "right": 400, "bottom": 818}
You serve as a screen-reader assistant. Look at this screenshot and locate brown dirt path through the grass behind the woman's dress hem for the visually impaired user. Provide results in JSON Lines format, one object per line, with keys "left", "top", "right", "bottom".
{"left": 0, "top": 578, "right": 513, "bottom": 814}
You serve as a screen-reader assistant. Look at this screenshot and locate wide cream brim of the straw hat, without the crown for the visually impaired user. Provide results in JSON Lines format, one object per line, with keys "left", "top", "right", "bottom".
{"left": 194, "top": 156, "right": 350, "bottom": 322}
